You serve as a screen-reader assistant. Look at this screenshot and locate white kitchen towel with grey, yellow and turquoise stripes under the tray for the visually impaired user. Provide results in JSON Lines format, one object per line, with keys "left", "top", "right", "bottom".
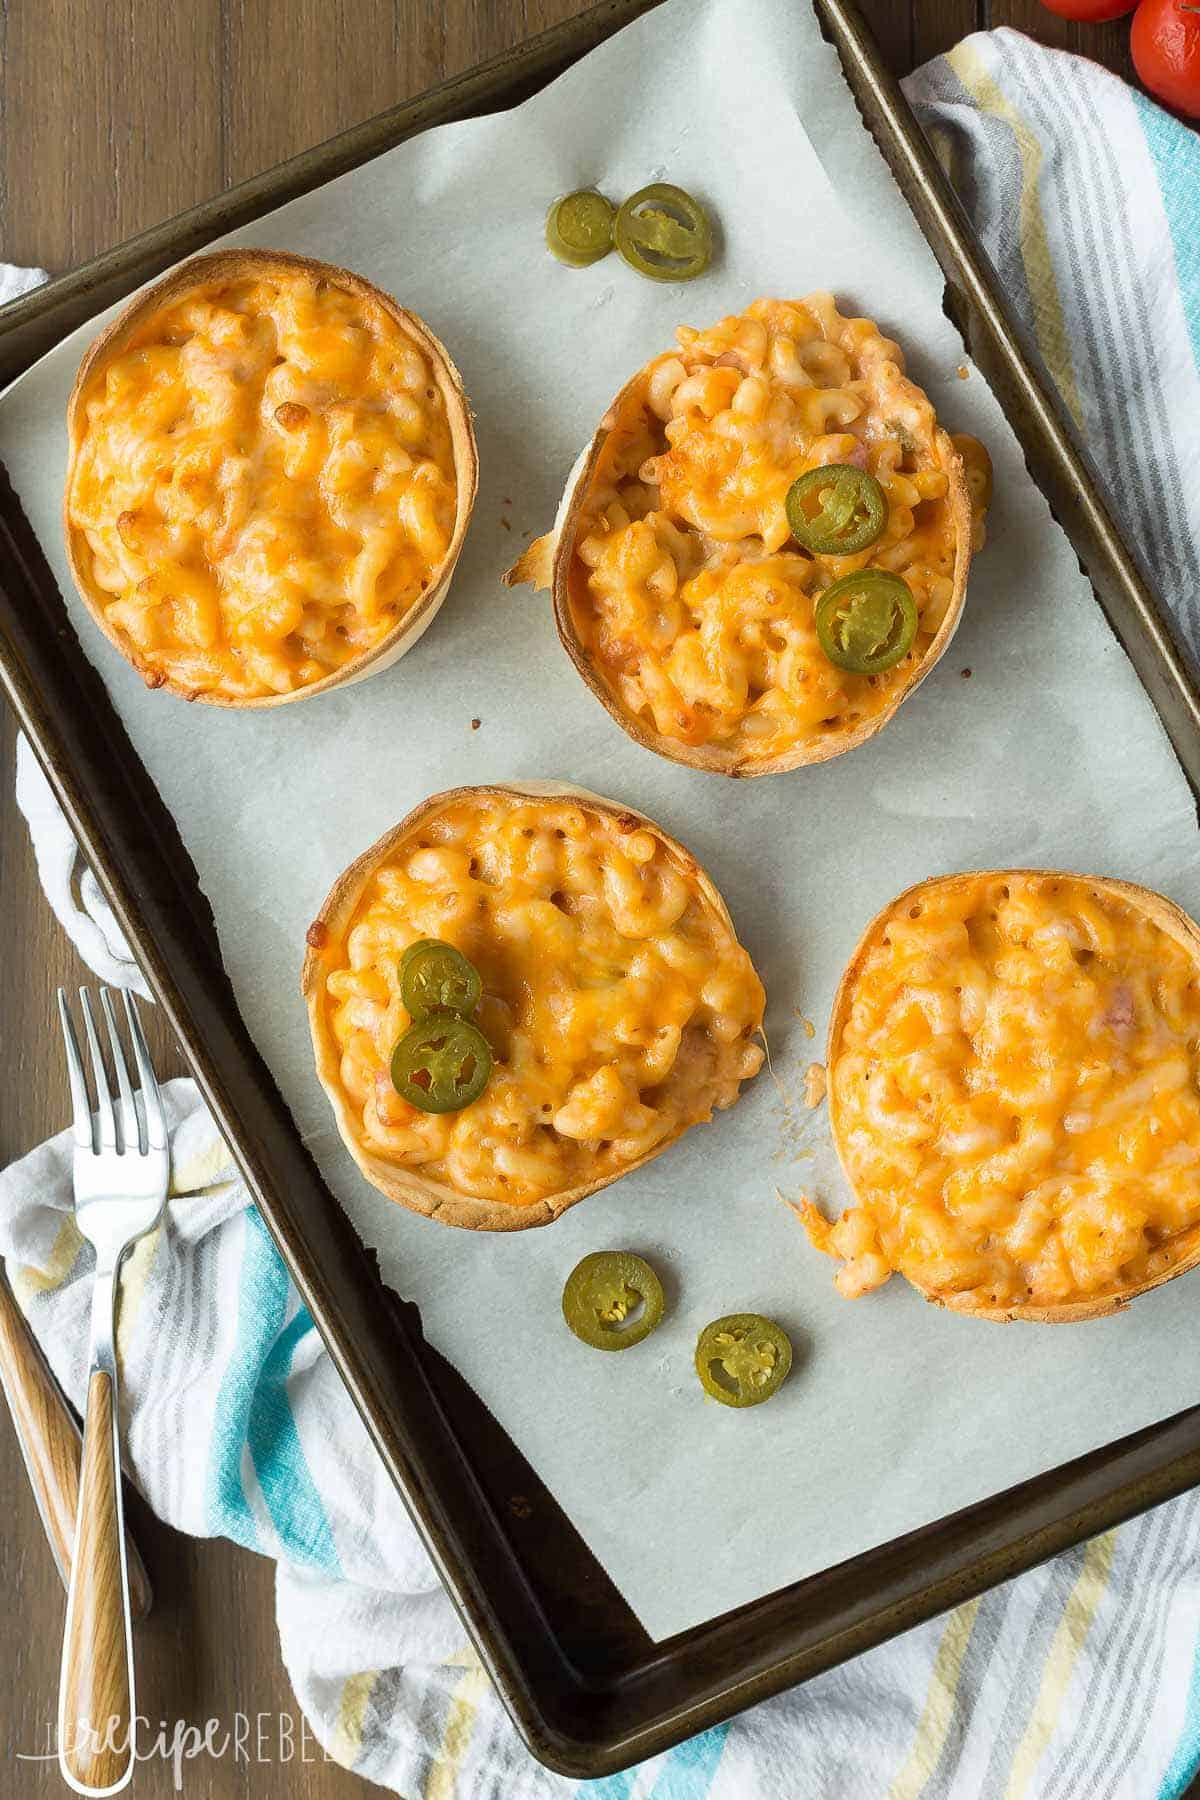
{"left": 0, "top": 31, "right": 1200, "bottom": 1800}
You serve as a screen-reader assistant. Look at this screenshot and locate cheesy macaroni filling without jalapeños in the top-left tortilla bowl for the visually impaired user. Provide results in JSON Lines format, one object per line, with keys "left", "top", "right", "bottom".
{"left": 67, "top": 268, "right": 457, "bottom": 702}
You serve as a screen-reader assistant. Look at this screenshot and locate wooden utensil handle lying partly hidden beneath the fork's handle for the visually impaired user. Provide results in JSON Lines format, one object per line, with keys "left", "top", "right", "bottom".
{"left": 0, "top": 1274, "right": 153, "bottom": 1618}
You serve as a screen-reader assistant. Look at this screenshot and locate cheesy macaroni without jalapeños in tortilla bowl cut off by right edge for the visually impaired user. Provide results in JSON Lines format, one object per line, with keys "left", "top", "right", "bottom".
{"left": 808, "top": 871, "right": 1200, "bottom": 1310}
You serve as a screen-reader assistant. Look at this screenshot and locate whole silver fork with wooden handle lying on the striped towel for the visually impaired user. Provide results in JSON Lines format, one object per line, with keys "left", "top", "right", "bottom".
{"left": 58, "top": 988, "right": 171, "bottom": 1795}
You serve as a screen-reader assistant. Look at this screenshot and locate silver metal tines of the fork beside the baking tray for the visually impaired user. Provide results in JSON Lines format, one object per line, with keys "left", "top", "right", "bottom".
{"left": 58, "top": 988, "right": 167, "bottom": 1156}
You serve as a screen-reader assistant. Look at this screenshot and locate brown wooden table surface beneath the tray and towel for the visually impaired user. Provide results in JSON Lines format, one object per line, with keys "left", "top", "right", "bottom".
{"left": 0, "top": 0, "right": 1180, "bottom": 1800}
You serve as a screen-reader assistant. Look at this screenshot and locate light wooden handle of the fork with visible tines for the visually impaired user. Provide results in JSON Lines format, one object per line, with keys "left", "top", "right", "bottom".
{"left": 58, "top": 1370, "right": 133, "bottom": 1795}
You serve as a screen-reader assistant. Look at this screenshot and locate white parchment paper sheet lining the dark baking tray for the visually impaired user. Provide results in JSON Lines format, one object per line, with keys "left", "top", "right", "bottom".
{"left": 0, "top": 0, "right": 1200, "bottom": 1636}
